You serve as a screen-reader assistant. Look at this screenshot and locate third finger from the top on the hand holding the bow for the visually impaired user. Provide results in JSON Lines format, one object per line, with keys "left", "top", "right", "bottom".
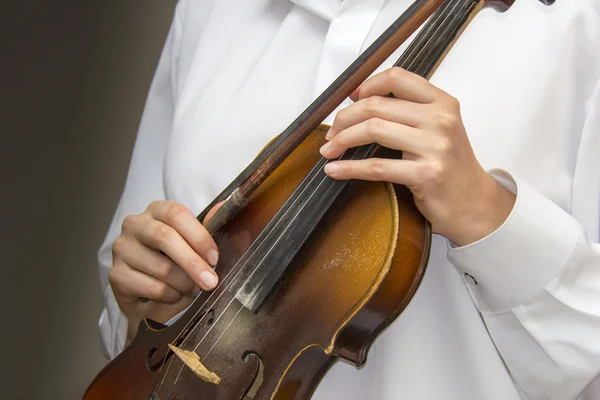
{"left": 119, "top": 240, "right": 200, "bottom": 297}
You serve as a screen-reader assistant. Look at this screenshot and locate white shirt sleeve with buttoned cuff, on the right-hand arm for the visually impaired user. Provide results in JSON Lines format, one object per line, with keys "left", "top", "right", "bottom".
{"left": 448, "top": 170, "right": 600, "bottom": 400}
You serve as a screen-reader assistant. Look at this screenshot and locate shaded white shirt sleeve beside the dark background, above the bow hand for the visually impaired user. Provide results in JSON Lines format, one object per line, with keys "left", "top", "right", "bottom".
{"left": 98, "top": 2, "right": 181, "bottom": 358}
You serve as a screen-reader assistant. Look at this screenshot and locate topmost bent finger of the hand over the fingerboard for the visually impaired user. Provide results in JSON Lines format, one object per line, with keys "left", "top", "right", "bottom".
{"left": 358, "top": 67, "right": 441, "bottom": 104}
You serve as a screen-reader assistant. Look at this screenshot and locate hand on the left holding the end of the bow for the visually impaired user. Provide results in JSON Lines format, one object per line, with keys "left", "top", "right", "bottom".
{"left": 108, "top": 201, "right": 219, "bottom": 339}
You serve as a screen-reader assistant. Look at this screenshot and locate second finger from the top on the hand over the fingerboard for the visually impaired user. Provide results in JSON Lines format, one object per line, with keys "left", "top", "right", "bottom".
{"left": 327, "top": 96, "right": 427, "bottom": 140}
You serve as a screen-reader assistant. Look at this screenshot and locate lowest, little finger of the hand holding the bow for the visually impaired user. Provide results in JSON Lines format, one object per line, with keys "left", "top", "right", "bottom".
{"left": 111, "top": 264, "right": 181, "bottom": 304}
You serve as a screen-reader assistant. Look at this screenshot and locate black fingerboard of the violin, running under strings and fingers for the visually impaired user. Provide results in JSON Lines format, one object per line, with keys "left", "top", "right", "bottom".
{"left": 195, "top": 0, "right": 490, "bottom": 318}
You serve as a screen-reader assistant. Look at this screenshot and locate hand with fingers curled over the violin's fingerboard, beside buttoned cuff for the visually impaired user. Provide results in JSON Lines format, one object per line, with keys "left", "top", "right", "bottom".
{"left": 321, "top": 67, "right": 515, "bottom": 246}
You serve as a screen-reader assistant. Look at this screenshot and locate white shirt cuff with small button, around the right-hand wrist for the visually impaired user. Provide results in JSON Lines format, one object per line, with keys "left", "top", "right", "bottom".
{"left": 448, "top": 170, "right": 579, "bottom": 312}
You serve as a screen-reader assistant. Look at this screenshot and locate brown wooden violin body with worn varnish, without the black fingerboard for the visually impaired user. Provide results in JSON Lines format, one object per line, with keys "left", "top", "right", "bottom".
{"left": 84, "top": 125, "right": 431, "bottom": 400}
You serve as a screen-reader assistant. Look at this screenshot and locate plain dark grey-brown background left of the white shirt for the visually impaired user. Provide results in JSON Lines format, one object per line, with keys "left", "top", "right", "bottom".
{"left": 0, "top": 0, "right": 176, "bottom": 400}
